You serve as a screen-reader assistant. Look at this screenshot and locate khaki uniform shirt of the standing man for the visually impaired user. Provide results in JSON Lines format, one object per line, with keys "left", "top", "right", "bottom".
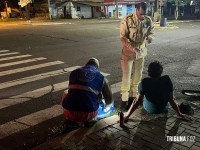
{"left": 120, "top": 13, "right": 153, "bottom": 58}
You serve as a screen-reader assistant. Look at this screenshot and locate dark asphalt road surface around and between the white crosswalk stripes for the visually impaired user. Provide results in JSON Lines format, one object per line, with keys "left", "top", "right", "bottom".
{"left": 0, "top": 22, "right": 200, "bottom": 149}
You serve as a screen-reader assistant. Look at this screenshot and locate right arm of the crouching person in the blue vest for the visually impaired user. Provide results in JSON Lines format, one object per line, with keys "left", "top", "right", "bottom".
{"left": 102, "top": 78, "right": 112, "bottom": 104}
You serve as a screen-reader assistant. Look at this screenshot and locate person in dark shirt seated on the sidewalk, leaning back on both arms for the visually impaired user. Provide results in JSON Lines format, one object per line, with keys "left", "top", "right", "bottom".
{"left": 124, "top": 61, "right": 190, "bottom": 121}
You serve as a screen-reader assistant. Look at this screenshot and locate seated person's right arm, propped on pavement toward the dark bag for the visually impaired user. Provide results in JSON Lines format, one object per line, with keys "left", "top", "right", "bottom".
{"left": 169, "top": 92, "right": 192, "bottom": 121}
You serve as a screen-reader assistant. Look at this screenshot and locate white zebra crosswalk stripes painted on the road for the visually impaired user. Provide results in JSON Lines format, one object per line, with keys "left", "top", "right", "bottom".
{"left": 0, "top": 50, "right": 121, "bottom": 140}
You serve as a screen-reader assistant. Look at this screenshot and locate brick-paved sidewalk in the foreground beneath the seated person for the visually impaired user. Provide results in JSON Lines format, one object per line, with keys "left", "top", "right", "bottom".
{"left": 33, "top": 104, "right": 200, "bottom": 150}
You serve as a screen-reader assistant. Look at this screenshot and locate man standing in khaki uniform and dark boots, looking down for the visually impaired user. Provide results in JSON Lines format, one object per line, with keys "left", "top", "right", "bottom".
{"left": 120, "top": 2, "right": 153, "bottom": 110}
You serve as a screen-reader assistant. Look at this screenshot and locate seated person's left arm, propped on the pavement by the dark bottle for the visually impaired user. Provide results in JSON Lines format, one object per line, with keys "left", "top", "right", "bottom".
{"left": 124, "top": 94, "right": 144, "bottom": 122}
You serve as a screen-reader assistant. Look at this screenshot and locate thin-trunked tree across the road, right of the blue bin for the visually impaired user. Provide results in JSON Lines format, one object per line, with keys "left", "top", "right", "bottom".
{"left": 168, "top": 0, "right": 190, "bottom": 20}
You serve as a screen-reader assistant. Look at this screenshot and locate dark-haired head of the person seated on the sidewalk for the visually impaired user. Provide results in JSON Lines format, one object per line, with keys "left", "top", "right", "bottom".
{"left": 148, "top": 61, "right": 163, "bottom": 78}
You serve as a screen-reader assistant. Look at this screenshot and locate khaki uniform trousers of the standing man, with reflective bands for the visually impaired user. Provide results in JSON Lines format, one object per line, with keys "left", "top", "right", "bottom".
{"left": 121, "top": 54, "right": 144, "bottom": 101}
